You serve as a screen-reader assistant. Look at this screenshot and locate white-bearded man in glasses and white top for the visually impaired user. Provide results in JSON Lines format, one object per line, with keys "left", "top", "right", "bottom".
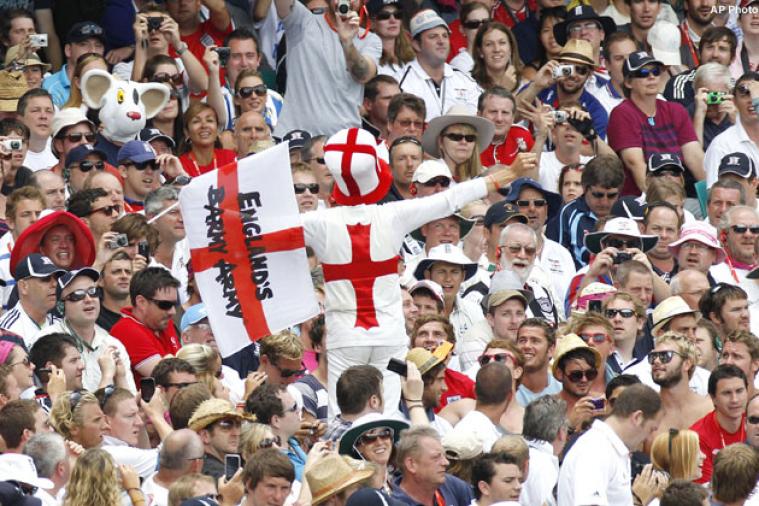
{"left": 490, "top": 223, "right": 564, "bottom": 325}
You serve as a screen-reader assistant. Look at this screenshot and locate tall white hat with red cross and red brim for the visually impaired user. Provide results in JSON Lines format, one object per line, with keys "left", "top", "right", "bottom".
{"left": 324, "top": 128, "right": 393, "bottom": 206}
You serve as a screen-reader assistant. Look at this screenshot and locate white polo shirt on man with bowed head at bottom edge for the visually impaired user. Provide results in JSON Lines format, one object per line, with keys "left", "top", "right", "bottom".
{"left": 558, "top": 420, "right": 633, "bottom": 506}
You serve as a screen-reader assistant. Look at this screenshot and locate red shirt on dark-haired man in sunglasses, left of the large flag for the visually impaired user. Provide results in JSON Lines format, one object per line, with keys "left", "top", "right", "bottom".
{"left": 111, "top": 307, "right": 180, "bottom": 384}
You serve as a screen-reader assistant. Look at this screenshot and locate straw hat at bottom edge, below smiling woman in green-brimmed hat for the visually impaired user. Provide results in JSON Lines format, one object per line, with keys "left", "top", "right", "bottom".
{"left": 302, "top": 452, "right": 374, "bottom": 506}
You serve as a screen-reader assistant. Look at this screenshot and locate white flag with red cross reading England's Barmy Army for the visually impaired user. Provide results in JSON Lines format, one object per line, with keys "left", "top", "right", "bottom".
{"left": 179, "top": 144, "right": 319, "bottom": 357}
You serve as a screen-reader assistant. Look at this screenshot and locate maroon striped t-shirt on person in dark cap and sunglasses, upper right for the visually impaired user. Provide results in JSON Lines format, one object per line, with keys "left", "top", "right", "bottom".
{"left": 606, "top": 99, "right": 698, "bottom": 195}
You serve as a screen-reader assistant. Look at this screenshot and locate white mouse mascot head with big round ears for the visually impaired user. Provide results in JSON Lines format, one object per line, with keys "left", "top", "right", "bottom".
{"left": 82, "top": 69, "right": 169, "bottom": 143}
